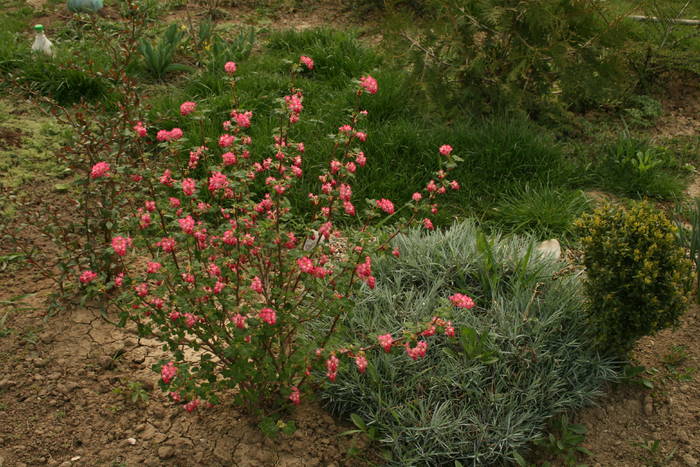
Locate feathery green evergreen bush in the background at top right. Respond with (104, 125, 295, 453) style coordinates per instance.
(401, 0, 629, 112)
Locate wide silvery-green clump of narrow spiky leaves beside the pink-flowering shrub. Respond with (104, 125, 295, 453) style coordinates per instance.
(322, 222, 615, 465)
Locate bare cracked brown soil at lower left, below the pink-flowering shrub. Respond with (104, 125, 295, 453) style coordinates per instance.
(0, 270, 360, 467)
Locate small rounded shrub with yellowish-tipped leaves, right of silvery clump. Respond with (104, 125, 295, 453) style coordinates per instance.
(577, 203, 691, 356)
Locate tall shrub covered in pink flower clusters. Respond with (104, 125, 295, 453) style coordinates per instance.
(98, 57, 473, 413)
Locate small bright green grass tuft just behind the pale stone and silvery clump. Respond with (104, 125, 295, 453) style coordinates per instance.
(491, 184, 589, 239)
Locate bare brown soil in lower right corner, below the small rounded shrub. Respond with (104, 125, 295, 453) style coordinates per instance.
(580, 305, 700, 467)
